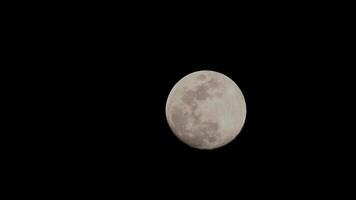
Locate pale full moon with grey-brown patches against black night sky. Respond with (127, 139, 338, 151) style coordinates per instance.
(166, 70, 246, 149)
